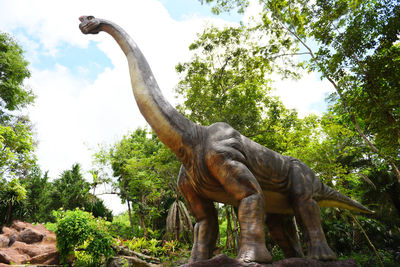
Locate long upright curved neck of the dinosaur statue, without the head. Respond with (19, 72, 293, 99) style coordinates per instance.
(100, 20, 196, 157)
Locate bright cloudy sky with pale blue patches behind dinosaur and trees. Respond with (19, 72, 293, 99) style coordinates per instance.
(0, 0, 332, 214)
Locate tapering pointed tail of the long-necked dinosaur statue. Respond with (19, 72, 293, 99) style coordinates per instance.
(315, 184, 375, 214)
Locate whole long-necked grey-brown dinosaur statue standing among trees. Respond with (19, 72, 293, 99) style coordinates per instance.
(79, 16, 373, 263)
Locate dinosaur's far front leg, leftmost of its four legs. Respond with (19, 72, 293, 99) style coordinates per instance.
(178, 167, 219, 262)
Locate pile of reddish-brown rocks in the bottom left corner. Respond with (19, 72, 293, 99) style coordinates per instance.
(0, 221, 59, 264)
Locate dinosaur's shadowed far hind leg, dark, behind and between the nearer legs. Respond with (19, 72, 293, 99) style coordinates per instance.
(265, 213, 304, 258)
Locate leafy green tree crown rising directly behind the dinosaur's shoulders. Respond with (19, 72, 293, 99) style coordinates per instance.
(176, 24, 300, 136)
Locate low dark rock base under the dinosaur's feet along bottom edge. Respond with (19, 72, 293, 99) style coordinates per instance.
(181, 254, 357, 267)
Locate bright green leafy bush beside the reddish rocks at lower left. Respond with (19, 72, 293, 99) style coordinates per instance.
(55, 209, 113, 266)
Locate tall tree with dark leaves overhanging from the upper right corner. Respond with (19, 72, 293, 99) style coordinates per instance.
(202, 0, 400, 209)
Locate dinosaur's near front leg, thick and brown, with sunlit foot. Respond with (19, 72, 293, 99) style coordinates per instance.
(208, 157, 272, 263)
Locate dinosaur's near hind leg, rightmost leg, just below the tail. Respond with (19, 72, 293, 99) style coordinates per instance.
(289, 163, 336, 261)
